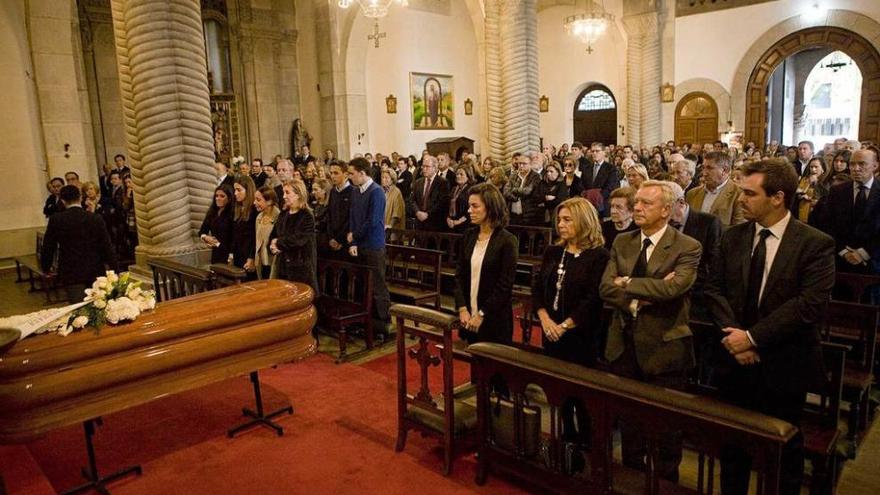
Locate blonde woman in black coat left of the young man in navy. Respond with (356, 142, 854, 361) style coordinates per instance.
(269, 180, 318, 295)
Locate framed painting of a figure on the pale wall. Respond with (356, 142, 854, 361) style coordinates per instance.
(409, 72, 455, 130)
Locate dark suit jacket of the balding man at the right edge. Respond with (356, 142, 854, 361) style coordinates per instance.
(818, 181, 880, 273)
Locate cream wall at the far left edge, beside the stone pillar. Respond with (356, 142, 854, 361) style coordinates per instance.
(0, 0, 47, 259)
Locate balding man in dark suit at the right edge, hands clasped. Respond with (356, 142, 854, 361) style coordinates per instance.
(818, 149, 880, 282)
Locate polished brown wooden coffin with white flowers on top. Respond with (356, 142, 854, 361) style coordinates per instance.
(0, 280, 317, 443)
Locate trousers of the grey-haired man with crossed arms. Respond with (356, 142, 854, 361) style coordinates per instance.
(611, 329, 687, 483)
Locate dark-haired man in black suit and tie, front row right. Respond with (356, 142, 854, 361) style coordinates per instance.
(706, 160, 834, 495)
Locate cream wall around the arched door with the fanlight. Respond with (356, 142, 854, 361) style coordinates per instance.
(538, 1, 626, 146)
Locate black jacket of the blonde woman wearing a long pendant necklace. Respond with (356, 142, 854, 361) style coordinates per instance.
(532, 246, 609, 366)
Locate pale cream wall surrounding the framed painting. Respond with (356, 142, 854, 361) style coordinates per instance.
(346, 0, 484, 156)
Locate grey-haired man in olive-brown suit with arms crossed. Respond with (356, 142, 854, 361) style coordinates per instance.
(599, 180, 702, 482)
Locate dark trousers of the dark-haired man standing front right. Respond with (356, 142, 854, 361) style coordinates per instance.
(720, 365, 806, 495)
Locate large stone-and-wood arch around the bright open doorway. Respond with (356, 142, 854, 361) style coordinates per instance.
(731, 10, 880, 147)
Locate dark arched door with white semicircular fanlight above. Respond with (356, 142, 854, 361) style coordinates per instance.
(573, 84, 617, 146)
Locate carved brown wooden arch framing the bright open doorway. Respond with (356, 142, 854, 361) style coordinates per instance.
(745, 26, 880, 147)
